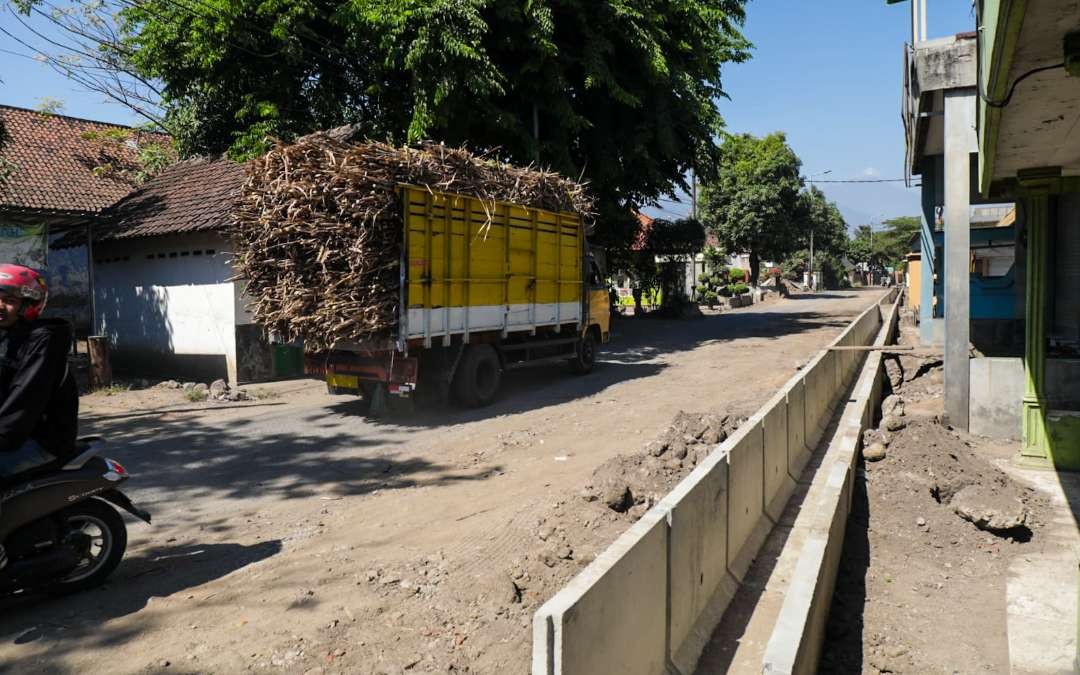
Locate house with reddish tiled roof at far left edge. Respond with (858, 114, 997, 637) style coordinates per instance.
(0, 105, 168, 336)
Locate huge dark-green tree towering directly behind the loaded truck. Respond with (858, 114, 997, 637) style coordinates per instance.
(17, 0, 751, 246)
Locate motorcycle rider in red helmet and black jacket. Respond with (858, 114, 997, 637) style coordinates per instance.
(0, 264, 79, 569)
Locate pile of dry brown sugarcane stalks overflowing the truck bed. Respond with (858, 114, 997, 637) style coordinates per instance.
(233, 132, 592, 351)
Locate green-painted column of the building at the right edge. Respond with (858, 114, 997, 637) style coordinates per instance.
(1021, 194, 1051, 463)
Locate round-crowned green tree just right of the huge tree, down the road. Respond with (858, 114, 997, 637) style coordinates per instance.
(700, 132, 805, 283)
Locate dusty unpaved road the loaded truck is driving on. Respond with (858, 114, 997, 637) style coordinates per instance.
(0, 291, 880, 674)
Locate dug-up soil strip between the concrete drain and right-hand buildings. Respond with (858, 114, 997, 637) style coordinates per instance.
(821, 321, 1050, 675)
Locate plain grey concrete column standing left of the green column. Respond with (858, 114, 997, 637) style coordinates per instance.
(945, 90, 977, 431)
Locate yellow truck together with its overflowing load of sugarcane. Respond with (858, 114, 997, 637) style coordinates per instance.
(233, 130, 610, 406)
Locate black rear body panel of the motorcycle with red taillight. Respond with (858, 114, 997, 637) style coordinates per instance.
(0, 457, 126, 542)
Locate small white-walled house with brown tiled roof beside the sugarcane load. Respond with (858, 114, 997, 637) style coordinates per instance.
(86, 158, 302, 383)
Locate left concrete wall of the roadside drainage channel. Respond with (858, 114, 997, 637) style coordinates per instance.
(532, 293, 892, 675)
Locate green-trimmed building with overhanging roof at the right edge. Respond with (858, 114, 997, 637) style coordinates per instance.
(976, 0, 1080, 470)
